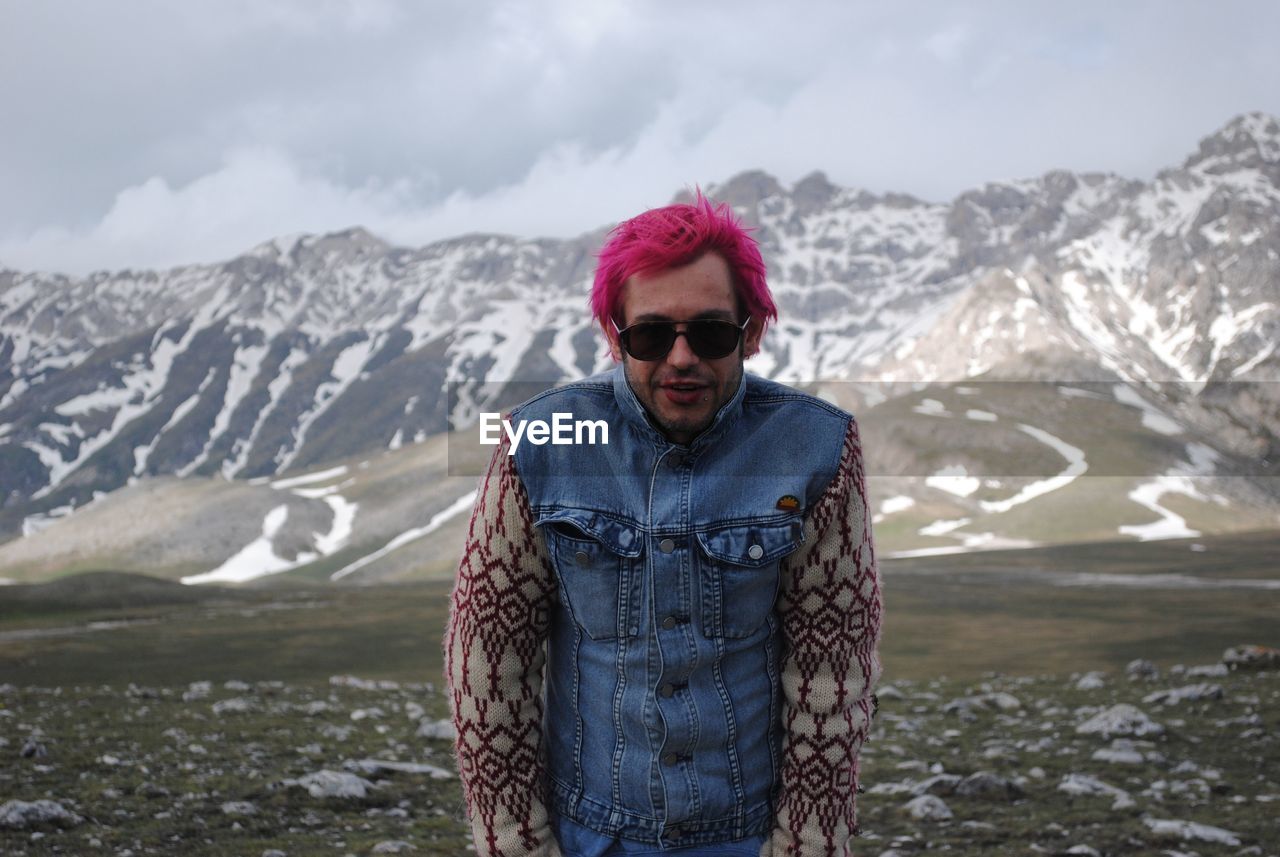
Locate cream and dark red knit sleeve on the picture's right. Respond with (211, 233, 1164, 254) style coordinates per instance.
(760, 420, 882, 857)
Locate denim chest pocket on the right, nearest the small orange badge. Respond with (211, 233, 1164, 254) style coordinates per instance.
(698, 518, 804, 638)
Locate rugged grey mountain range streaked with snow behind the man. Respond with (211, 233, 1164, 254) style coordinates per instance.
(0, 114, 1280, 583)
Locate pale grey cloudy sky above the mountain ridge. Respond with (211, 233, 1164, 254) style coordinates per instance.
(0, 0, 1280, 272)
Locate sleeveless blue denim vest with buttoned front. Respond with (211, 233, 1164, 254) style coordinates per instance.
(511, 365, 851, 847)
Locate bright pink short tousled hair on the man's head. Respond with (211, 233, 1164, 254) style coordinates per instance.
(591, 189, 778, 335)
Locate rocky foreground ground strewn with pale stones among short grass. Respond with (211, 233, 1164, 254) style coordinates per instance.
(0, 661, 1280, 857)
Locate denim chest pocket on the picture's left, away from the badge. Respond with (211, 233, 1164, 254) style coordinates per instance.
(538, 513, 641, 640)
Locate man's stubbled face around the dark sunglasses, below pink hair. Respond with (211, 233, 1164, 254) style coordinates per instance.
(607, 252, 760, 445)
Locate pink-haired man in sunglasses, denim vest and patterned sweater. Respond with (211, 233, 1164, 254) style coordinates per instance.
(445, 193, 882, 857)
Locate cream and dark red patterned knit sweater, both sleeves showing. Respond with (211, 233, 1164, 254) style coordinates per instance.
(444, 421, 882, 857)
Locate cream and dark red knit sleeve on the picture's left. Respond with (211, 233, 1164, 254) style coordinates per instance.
(444, 441, 561, 857)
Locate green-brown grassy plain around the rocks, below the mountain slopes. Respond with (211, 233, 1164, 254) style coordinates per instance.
(0, 533, 1280, 856)
